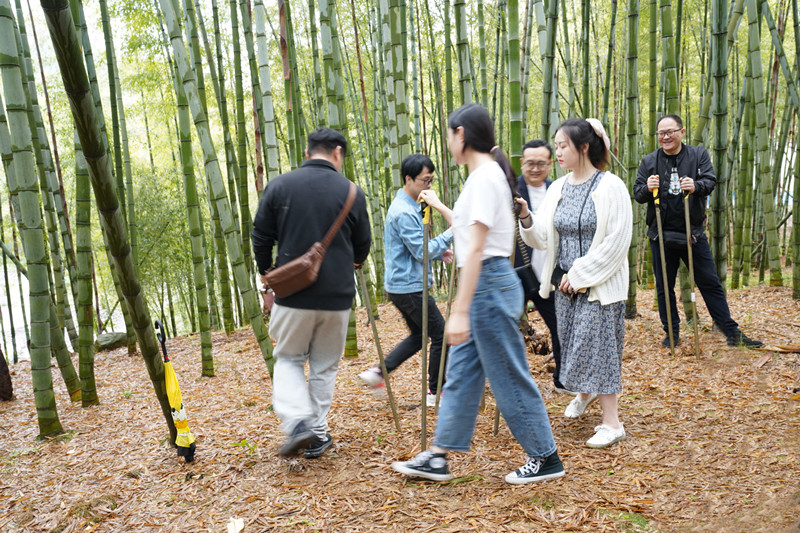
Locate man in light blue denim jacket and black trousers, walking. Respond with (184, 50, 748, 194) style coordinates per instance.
(358, 154, 453, 407)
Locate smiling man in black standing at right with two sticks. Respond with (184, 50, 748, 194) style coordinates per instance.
(633, 115, 762, 347)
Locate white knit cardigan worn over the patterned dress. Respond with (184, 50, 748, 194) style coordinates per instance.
(520, 172, 633, 305)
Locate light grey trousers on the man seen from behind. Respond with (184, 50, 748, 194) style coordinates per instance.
(269, 304, 350, 437)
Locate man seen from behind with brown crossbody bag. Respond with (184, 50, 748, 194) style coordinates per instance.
(252, 128, 372, 458)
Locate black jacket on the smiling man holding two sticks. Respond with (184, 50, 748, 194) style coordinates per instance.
(633, 144, 717, 239)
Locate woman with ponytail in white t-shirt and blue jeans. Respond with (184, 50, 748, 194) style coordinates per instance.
(392, 104, 564, 484)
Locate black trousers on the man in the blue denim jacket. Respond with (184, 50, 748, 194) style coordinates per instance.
(386, 292, 447, 394)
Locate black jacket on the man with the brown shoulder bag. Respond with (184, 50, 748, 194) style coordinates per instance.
(252, 159, 372, 311)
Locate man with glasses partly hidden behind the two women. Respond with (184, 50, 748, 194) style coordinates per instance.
(514, 139, 565, 392)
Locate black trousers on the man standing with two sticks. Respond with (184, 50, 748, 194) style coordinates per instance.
(650, 234, 739, 338)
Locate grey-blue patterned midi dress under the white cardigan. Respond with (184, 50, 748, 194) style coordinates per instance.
(553, 179, 625, 394)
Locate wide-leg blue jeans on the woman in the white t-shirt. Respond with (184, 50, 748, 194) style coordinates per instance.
(434, 257, 556, 457)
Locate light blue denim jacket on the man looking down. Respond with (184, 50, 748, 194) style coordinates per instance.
(383, 189, 453, 294)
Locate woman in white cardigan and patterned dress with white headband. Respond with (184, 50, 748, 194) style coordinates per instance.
(517, 118, 633, 448)
